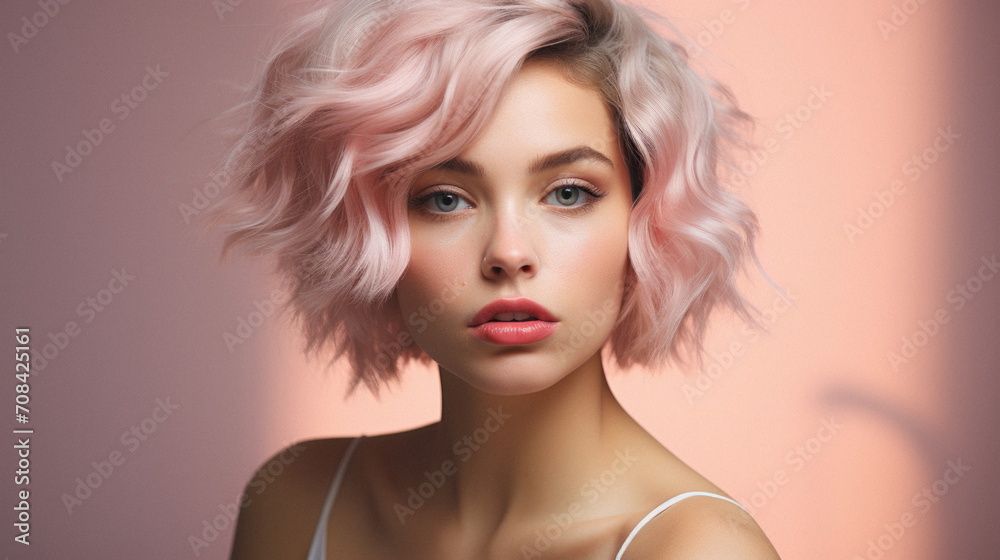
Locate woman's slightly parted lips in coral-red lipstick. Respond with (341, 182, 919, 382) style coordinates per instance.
(469, 297, 559, 346)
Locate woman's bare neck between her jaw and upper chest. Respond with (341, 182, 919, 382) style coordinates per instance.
(434, 353, 631, 524)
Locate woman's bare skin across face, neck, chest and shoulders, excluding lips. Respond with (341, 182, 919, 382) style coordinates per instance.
(232, 61, 778, 560)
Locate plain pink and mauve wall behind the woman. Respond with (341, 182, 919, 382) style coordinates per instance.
(0, 0, 1000, 560)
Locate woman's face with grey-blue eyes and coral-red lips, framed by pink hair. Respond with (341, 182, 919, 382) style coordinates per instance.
(397, 61, 632, 395)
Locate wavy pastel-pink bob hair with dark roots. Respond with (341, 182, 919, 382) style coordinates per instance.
(216, 0, 758, 391)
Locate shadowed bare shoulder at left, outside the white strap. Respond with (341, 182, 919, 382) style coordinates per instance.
(230, 438, 360, 560)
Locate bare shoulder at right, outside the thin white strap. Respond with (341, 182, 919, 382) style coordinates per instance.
(623, 496, 780, 560)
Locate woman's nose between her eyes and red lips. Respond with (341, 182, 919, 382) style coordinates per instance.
(482, 211, 538, 280)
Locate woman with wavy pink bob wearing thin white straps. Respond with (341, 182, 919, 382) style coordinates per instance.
(217, 0, 777, 560)
